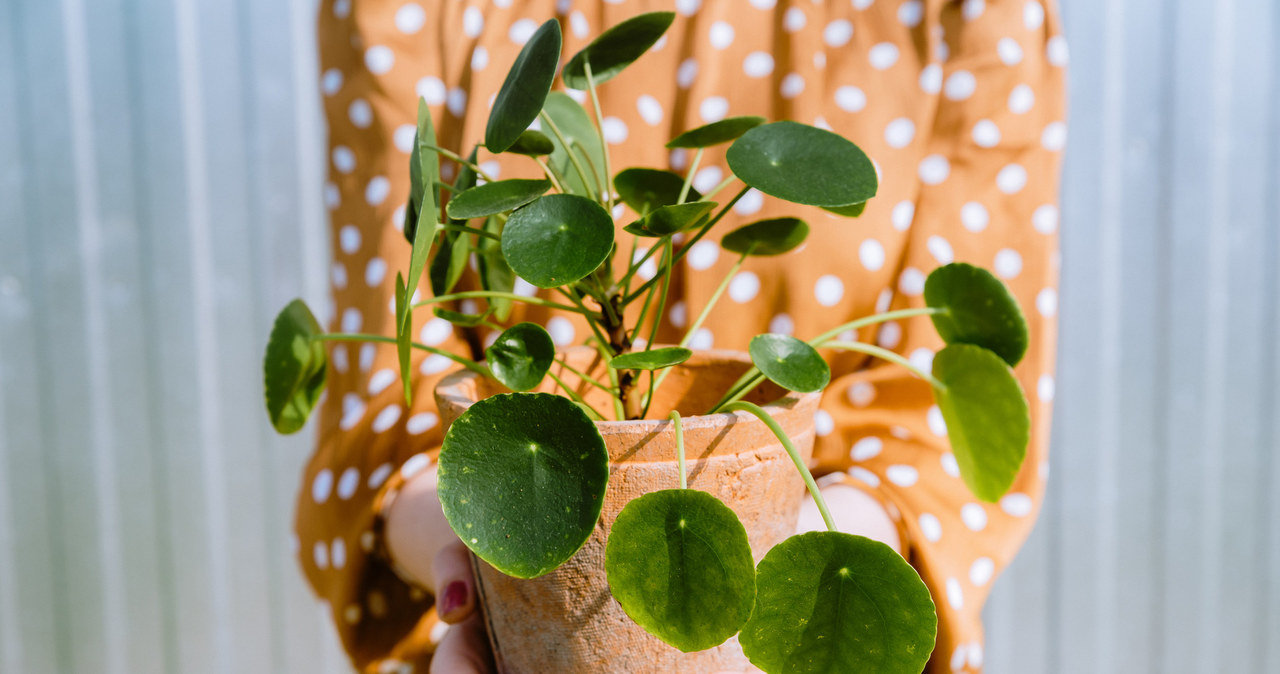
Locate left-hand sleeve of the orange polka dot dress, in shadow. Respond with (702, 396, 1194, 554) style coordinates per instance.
(294, 0, 476, 673)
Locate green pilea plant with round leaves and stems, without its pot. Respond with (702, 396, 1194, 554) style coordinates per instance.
(264, 13, 1029, 673)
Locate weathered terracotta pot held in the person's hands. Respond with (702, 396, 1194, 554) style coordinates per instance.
(435, 347, 820, 674)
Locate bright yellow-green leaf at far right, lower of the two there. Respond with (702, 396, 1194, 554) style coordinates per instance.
(933, 344, 1030, 503)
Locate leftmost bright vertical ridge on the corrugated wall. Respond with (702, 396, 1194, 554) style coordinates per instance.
(61, 0, 128, 674)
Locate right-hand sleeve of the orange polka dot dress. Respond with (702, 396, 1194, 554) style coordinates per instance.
(815, 3, 1065, 673)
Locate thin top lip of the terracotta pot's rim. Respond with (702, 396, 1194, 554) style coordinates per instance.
(435, 345, 824, 435)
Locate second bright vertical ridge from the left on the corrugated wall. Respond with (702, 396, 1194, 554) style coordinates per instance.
(174, 0, 233, 674)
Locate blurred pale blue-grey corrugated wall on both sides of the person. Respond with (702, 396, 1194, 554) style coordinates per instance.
(0, 0, 1280, 674)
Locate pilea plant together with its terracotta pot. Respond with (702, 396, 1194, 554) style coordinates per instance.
(264, 13, 1029, 673)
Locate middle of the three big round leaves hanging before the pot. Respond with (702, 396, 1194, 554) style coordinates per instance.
(604, 489, 755, 652)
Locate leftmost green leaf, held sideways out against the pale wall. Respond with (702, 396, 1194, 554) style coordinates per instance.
(262, 299, 329, 434)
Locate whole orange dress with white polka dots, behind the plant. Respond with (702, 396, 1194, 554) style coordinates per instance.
(296, 0, 1068, 673)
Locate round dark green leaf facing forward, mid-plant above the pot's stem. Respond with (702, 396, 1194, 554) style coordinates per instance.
(502, 194, 613, 288)
